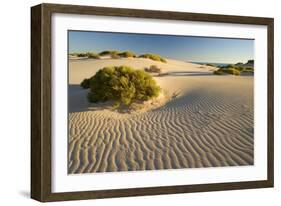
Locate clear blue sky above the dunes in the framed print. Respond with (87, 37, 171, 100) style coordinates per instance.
(69, 31, 254, 63)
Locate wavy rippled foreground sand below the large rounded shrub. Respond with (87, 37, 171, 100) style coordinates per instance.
(68, 84, 254, 173)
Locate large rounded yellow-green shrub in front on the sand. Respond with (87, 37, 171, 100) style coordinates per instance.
(84, 66, 160, 108)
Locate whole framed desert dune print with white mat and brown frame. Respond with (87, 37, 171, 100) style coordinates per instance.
(31, 4, 274, 202)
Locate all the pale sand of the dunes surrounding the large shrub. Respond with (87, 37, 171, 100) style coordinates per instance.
(68, 58, 254, 174)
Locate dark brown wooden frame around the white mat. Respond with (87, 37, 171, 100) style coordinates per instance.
(31, 4, 274, 202)
